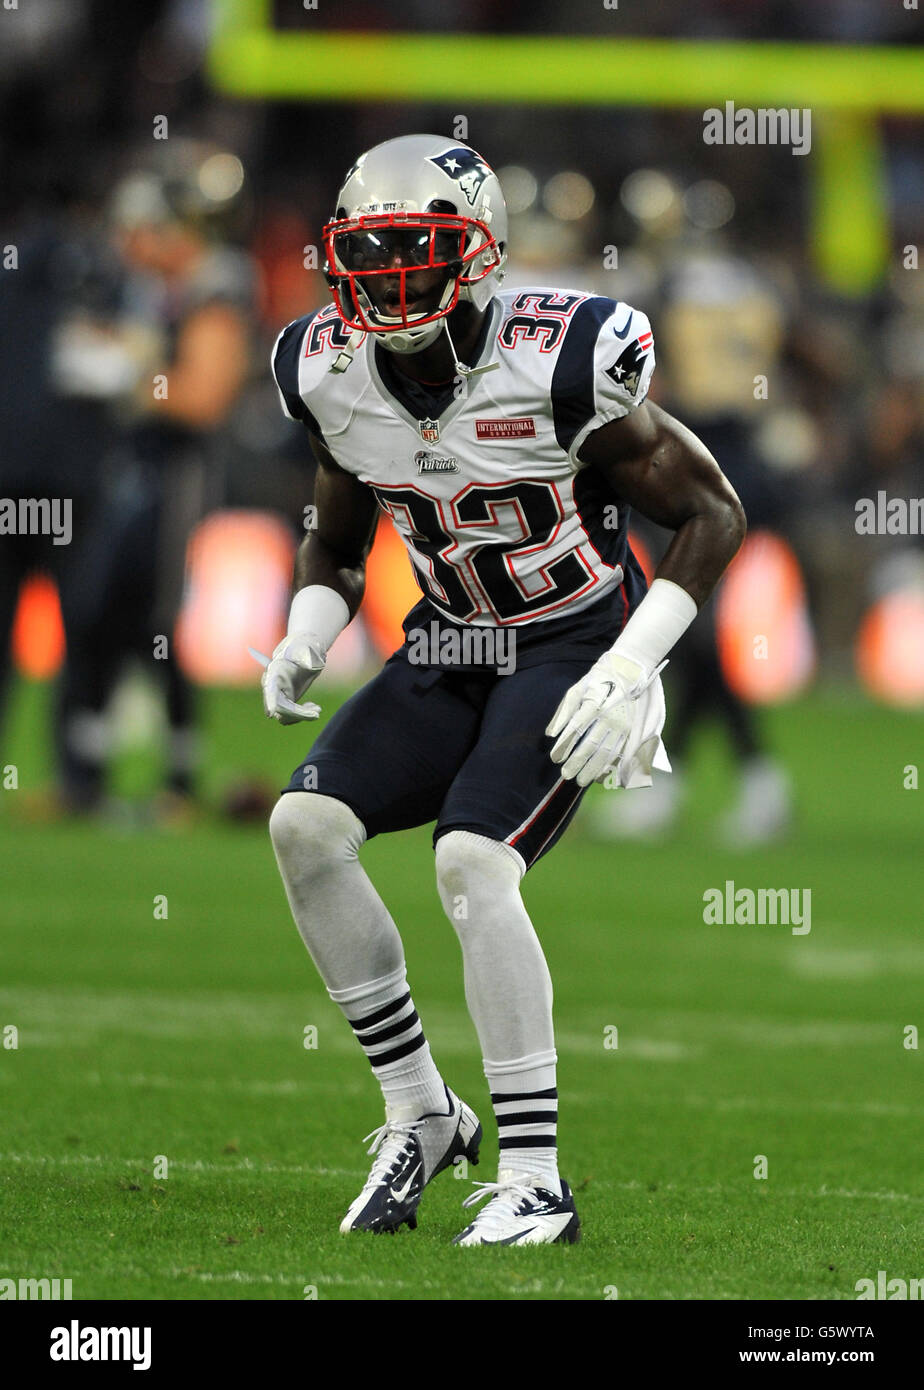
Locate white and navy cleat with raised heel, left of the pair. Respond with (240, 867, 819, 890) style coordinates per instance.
(340, 1087, 481, 1236)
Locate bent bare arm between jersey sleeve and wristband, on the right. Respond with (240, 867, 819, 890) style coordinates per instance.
(579, 400, 746, 607)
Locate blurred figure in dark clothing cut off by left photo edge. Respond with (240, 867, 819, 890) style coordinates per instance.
(0, 207, 126, 801)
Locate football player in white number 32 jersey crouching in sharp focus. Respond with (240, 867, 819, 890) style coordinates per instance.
(263, 135, 745, 1245)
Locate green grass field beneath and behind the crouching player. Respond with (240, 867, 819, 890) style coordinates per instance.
(0, 687, 924, 1300)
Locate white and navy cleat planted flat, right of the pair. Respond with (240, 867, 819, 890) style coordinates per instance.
(453, 1173, 581, 1245)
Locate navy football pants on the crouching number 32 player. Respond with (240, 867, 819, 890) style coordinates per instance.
(283, 653, 591, 869)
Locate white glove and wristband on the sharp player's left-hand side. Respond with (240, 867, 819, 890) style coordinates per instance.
(249, 584, 350, 724)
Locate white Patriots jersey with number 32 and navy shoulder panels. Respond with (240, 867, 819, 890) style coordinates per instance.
(272, 288, 654, 626)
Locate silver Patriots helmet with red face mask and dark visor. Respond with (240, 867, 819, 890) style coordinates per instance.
(324, 135, 507, 353)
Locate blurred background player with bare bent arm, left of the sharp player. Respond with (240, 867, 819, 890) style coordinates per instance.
(64, 142, 254, 819)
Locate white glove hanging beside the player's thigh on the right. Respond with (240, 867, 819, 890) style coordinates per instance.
(546, 652, 667, 787)
